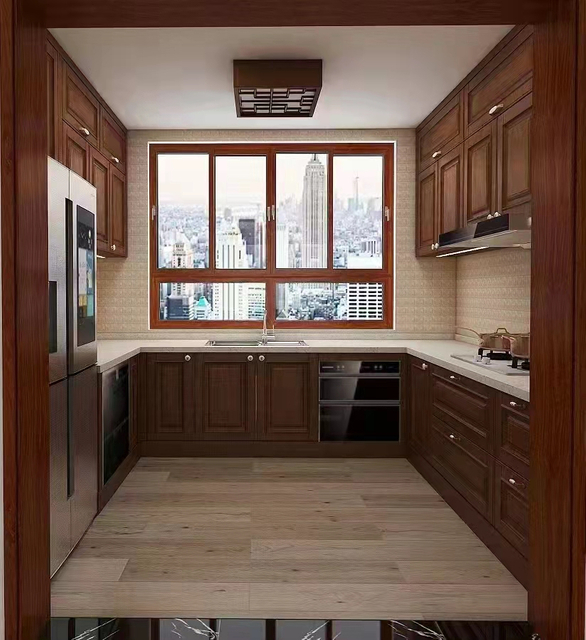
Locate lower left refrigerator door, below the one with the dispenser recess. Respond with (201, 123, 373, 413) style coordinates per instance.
(49, 380, 71, 576)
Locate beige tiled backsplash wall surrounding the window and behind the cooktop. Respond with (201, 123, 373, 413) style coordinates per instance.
(98, 129, 529, 338)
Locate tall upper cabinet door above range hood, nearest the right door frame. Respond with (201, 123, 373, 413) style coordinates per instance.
(497, 94, 533, 213)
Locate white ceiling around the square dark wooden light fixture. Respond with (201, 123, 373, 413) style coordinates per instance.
(52, 26, 510, 129)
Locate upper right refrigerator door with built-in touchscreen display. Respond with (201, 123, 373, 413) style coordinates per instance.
(67, 173, 97, 375)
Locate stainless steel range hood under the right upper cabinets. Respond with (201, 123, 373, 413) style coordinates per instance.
(438, 213, 531, 258)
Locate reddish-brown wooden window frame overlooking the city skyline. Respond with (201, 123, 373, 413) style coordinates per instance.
(149, 142, 395, 330)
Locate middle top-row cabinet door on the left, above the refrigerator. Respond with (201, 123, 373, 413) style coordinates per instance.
(63, 63, 100, 148)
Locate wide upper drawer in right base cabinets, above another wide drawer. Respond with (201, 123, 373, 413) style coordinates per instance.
(431, 366, 494, 453)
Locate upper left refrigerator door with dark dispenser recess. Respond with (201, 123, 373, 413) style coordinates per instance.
(48, 158, 69, 383)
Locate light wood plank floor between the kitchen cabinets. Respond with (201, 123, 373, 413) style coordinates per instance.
(52, 458, 527, 620)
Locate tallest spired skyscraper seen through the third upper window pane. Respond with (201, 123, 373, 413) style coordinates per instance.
(301, 153, 328, 269)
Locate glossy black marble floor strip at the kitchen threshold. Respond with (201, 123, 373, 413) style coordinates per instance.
(50, 618, 532, 640)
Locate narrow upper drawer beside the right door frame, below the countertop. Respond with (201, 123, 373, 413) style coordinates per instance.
(495, 394, 529, 478)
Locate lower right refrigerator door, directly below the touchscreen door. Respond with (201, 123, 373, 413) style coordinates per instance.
(68, 366, 98, 547)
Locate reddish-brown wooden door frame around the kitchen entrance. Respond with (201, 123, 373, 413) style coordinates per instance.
(0, 0, 586, 640)
